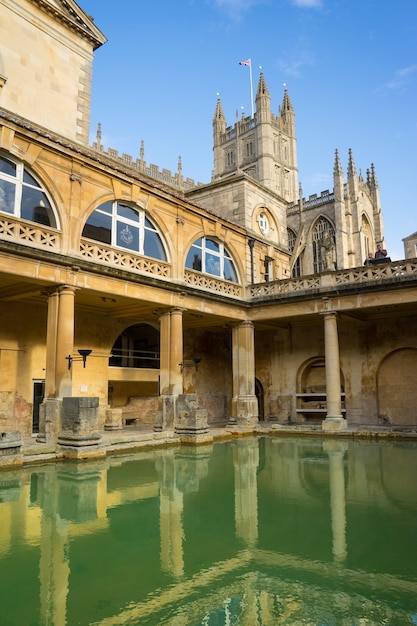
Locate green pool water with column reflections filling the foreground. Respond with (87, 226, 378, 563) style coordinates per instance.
(0, 437, 417, 626)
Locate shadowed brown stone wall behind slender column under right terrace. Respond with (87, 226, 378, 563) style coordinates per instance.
(256, 315, 417, 425)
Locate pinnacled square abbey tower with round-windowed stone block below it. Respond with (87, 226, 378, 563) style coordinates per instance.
(185, 72, 298, 282)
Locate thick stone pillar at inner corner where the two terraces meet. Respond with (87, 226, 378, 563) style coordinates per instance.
(231, 321, 258, 426)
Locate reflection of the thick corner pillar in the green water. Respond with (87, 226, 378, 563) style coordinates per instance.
(233, 439, 259, 545)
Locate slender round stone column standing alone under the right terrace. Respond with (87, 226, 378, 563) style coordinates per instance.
(322, 311, 347, 430)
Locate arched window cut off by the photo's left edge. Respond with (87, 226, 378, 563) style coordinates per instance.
(0, 157, 57, 228)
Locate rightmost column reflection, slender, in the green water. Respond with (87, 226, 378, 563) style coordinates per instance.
(323, 441, 347, 561)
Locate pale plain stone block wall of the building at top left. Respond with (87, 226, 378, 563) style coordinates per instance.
(0, 2, 100, 144)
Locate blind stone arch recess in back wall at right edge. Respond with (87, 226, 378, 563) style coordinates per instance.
(376, 348, 417, 425)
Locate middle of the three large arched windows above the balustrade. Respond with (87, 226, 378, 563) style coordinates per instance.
(82, 200, 167, 261)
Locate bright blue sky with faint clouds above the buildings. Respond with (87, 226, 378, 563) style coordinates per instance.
(78, 0, 417, 259)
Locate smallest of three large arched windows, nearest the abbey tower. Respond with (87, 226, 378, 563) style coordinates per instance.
(185, 237, 238, 283)
